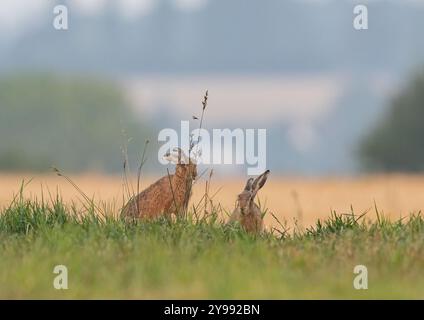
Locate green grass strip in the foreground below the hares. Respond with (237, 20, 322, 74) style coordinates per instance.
(0, 192, 424, 299)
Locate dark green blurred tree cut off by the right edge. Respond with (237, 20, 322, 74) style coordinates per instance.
(359, 70, 424, 172)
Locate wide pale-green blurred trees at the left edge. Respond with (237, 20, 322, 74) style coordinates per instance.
(0, 74, 150, 171)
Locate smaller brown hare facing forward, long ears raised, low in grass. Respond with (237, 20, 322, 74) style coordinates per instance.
(230, 170, 270, 233)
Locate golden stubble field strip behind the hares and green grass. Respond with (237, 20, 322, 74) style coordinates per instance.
(0, 173, 424, 227)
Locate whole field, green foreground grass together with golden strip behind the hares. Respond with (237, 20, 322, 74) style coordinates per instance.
(0, 174, 424, 299)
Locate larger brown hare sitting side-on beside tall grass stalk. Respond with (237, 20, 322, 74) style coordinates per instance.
(121, 148, 197, 218)
